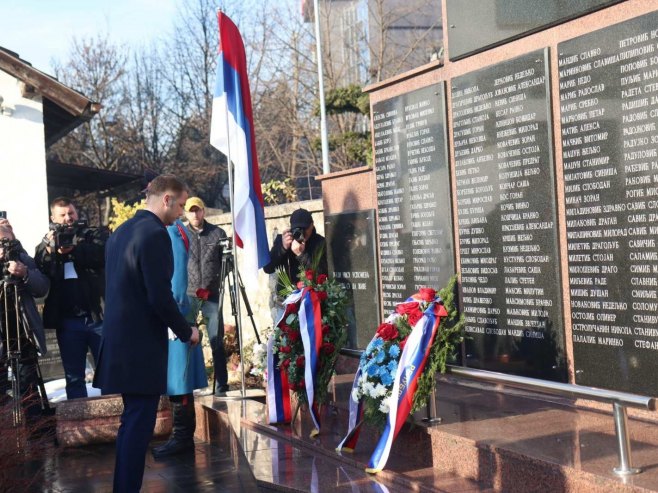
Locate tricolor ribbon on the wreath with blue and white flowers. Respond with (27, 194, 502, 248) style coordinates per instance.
(337, 297, 448, 474)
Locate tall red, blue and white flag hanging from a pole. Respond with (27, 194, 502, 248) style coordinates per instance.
(210, 12, 270, 286)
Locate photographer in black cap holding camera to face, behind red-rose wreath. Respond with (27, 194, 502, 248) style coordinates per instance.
(263, 209, 328, 293)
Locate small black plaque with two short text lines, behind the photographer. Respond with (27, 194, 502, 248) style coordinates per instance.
(324, 209, 381, 349)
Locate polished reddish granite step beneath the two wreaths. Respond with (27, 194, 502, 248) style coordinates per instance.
(197, 397, 493, 493)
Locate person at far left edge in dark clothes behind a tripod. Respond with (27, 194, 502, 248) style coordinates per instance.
(0, 221, 50, 422)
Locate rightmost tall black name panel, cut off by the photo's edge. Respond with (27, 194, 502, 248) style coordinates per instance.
(558, 13, 658, 395)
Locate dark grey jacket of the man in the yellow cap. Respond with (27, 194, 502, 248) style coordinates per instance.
(187, 221, 226, 302)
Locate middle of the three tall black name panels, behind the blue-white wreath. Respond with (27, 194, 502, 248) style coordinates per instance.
(452, 49, 567, 381)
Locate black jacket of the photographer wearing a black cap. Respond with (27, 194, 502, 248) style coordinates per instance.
(263, 229, 328, 293)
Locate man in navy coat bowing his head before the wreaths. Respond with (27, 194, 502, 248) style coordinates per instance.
(94, 175, 199, 493)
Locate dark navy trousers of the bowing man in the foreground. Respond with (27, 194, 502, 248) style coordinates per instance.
(114, 394, 160, 493)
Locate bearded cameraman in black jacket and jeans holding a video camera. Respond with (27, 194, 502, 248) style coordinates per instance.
(35, 197, 107, 399)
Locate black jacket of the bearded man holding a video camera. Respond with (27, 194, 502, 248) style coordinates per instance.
(34, 229, 107, 329)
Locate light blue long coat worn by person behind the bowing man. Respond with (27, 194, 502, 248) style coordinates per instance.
(167, 221, 208, 395)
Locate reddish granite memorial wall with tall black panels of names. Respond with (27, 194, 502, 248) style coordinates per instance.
(346, 0, 658, 396)
